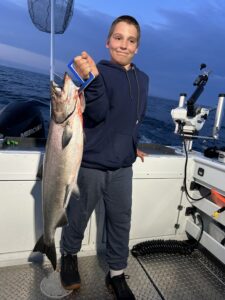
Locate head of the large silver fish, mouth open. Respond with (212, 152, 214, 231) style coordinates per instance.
(51, 73, 81, 124)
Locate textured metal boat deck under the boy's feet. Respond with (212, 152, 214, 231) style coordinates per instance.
(0, 250, 225, 300)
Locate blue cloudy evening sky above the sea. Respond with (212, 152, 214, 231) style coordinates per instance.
(0, 0, 225, 107)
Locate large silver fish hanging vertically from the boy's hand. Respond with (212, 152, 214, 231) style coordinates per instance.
(33, 73, 85, 270)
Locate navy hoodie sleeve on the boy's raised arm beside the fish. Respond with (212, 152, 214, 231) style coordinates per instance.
(85, 74, 109, 123)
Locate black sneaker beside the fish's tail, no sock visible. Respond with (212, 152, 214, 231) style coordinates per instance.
(60, 254, 81, 290)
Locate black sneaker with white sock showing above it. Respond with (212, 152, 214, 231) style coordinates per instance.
(105, 272, 135, 300)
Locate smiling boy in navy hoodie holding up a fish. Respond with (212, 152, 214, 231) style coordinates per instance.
(61, 15, 149, 299)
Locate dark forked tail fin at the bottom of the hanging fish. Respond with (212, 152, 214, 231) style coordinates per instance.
(33, 235, 57, 270)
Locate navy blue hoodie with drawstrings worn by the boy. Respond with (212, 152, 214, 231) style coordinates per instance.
(82, 61, 149, 170)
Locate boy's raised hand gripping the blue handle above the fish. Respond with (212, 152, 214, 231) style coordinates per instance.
(74, 51, 99, 79)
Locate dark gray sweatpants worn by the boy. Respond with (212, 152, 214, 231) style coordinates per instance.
(61, 167, 133, 270)
